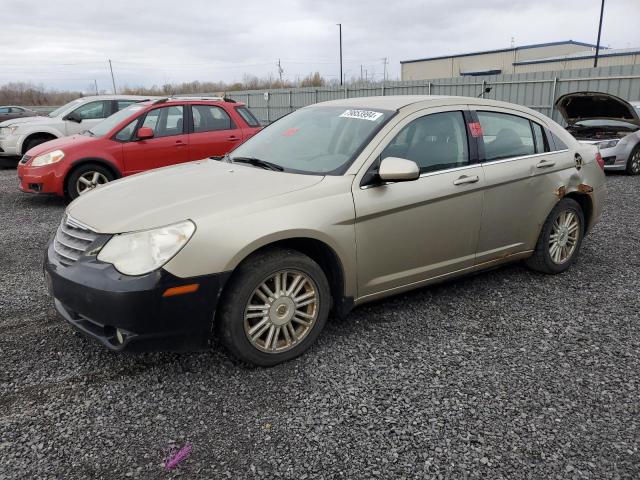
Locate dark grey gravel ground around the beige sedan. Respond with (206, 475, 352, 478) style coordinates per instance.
(0, 170, 640, 479)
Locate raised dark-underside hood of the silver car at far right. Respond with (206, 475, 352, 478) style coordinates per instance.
(555, 92, 640, 126)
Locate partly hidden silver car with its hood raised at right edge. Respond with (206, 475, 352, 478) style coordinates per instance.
(556, 92, 640, 175)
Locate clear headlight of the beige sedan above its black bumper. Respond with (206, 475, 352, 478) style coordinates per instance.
(98, 220, 196, 275)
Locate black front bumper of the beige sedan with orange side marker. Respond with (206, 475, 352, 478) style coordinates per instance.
(44, 239, 228, 351)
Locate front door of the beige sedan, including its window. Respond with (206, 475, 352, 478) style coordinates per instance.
(353, 107, 484, 298)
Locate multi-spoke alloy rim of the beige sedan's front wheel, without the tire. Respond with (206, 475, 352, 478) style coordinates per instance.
(244, 270, 320, 353)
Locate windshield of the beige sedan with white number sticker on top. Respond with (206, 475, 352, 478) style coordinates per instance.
(230, 106, 394, 175)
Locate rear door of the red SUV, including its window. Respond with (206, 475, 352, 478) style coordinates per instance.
(189, 104, 243, 160)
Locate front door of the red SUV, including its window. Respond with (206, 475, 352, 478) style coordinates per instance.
(122, 105, 189, 174)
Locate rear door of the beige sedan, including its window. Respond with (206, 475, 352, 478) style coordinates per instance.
(475, 106, 575, 264)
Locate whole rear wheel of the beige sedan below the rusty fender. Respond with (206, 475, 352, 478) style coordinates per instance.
(525, 198, 585, 274)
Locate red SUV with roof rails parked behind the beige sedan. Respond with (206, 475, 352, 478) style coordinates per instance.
(18, 97, 262, 199)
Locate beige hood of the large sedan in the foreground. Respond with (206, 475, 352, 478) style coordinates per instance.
(67, 160, 324, 233)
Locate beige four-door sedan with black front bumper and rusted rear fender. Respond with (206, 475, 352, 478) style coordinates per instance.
(44, 96, 605, 366)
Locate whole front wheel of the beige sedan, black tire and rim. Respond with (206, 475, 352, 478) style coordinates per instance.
(216, 249, 331, 367)
